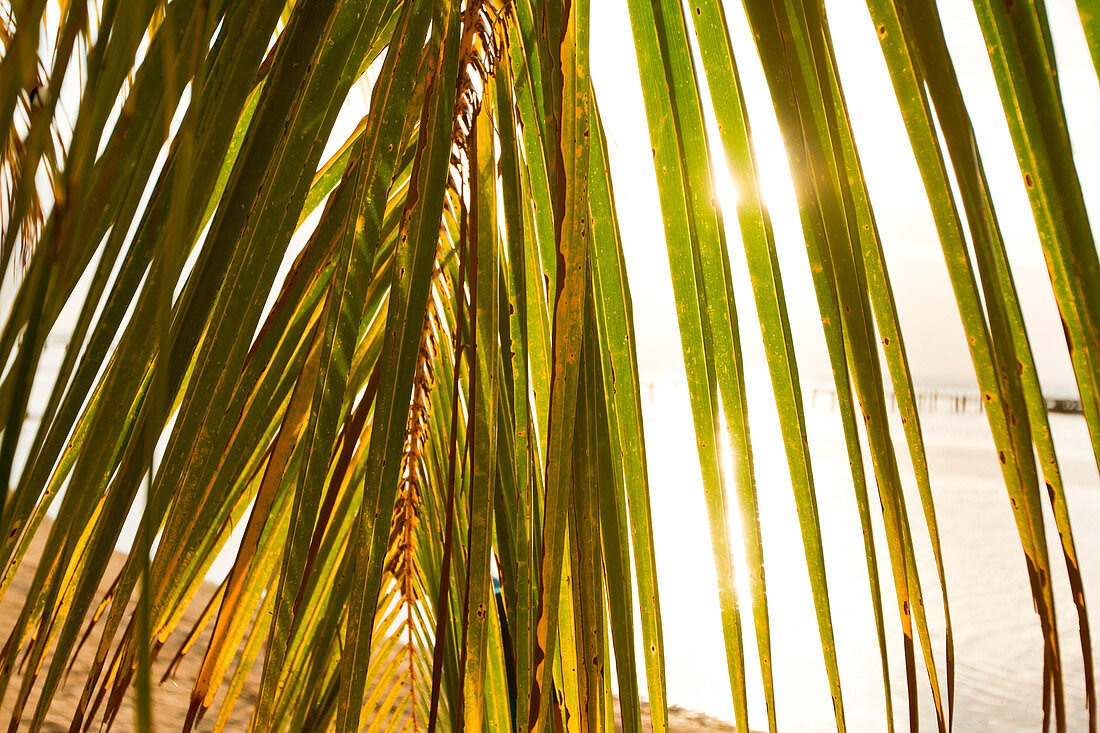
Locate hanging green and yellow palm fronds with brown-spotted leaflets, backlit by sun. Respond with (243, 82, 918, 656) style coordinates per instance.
(0, 0, 1100, 731)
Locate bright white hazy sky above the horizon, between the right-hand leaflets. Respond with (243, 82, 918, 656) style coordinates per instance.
(592, 0, 1100, 395)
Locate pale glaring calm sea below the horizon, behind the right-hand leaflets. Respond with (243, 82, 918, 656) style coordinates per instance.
(644, 382, 1100, 732)
